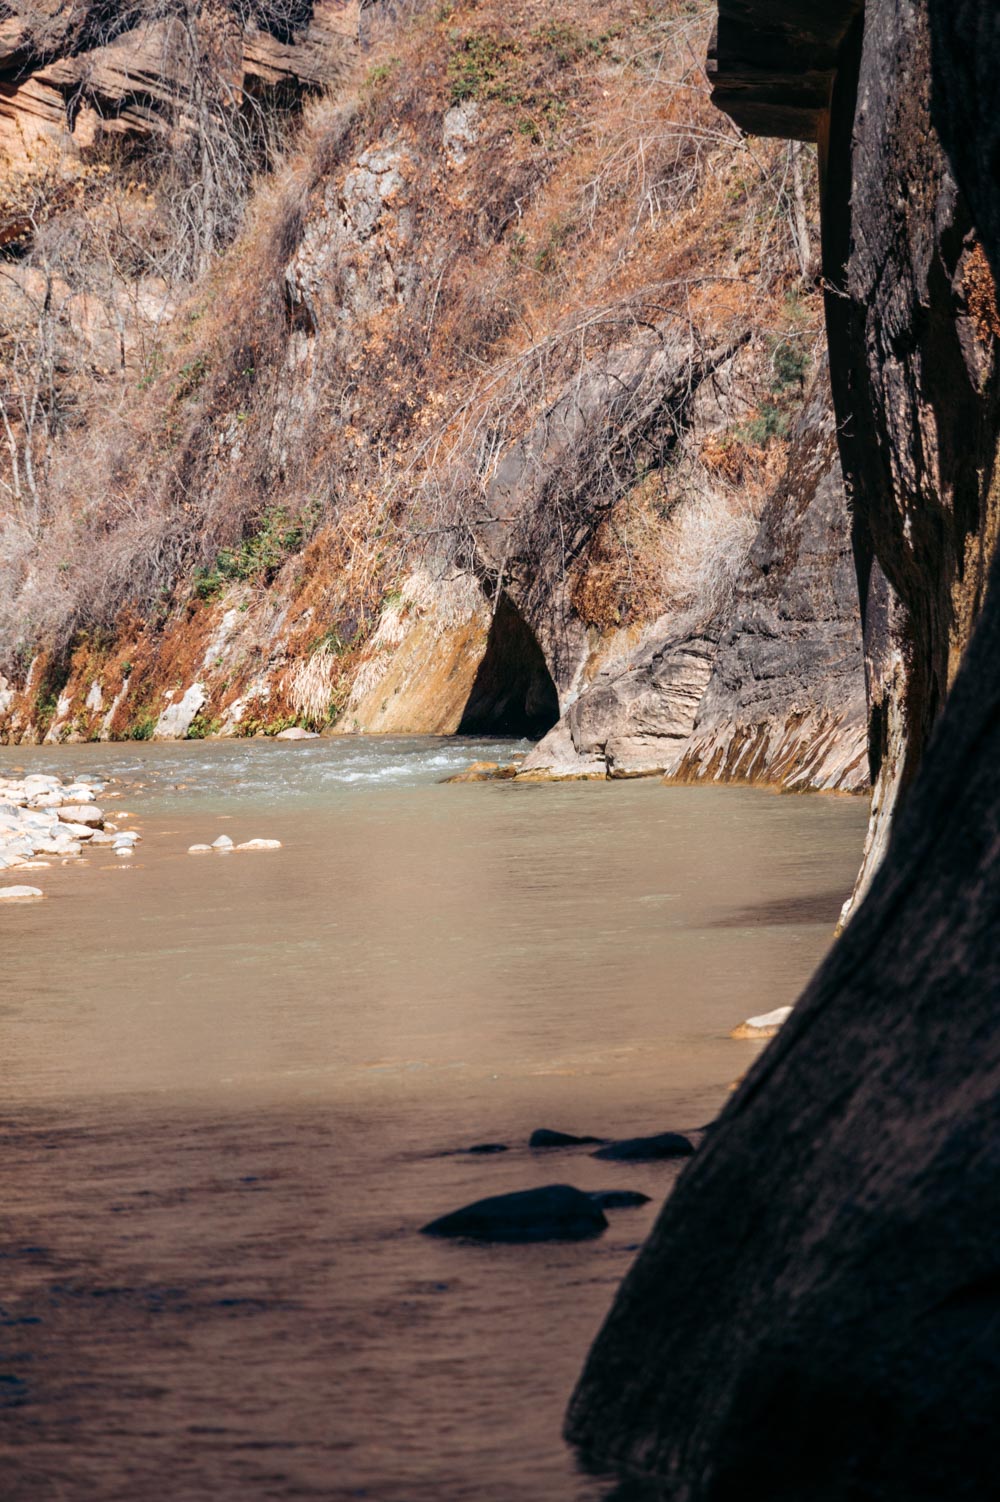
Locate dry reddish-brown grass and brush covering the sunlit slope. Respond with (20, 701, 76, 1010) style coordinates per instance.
(0, 0, 818, 720)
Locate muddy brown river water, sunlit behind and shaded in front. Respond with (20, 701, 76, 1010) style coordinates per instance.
(0, 739, 866, 1502)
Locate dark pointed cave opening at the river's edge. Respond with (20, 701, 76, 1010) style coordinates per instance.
(458, 593, 559, 740)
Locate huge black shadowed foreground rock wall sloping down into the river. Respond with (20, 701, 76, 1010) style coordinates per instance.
(569, 0, 1000, 1502)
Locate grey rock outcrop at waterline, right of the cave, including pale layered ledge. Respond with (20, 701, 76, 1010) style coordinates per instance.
(520, 372, 868, 792)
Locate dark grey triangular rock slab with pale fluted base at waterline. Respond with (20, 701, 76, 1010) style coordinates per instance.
(673, 361, 868, 792)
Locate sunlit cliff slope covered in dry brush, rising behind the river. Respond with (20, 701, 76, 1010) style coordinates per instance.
(0, 0, 866, 790)
